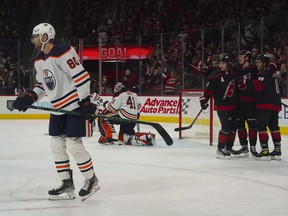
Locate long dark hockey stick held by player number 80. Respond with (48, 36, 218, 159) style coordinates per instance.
(27, 106, 173, 146)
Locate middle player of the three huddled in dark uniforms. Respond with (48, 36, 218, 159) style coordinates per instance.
(233, 50, 257, 156)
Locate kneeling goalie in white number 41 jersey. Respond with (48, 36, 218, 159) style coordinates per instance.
(93, 82, 156, 146)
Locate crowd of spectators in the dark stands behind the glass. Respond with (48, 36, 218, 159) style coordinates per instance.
(0, 0, 288, 96)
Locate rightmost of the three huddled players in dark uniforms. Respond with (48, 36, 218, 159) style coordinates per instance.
(247, 54, 281, 160)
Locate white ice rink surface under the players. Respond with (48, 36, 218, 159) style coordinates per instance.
(0, 120, 288, 216)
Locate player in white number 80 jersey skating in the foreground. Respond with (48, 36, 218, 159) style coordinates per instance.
(13, 23, 99, 200)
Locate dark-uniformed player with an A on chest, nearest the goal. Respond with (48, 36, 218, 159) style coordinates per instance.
(200, 54, 237, 158)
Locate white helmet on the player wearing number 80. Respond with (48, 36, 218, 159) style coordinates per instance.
(31, 23, 56, 50)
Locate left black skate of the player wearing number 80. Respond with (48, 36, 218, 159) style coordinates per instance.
(48, 170, 75, 200)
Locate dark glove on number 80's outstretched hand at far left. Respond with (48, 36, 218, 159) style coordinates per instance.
(13, 90, 38, 112)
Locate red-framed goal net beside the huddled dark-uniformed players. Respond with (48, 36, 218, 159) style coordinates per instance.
(179, 90, 214, 145)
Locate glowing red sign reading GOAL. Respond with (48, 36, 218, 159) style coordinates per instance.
(83, 45, 153, 60)
